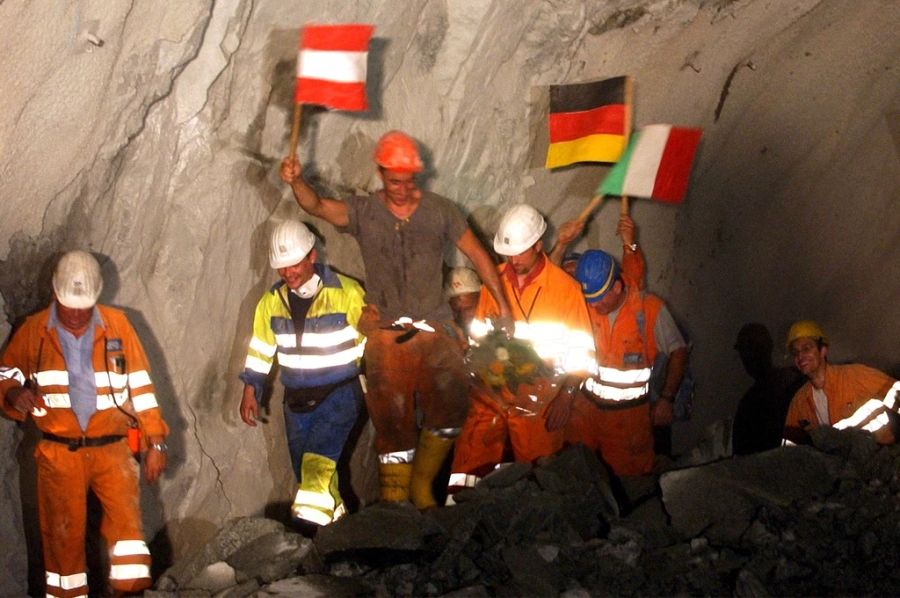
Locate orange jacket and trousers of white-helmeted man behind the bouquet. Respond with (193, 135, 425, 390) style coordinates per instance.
(451, 256, 593, 478)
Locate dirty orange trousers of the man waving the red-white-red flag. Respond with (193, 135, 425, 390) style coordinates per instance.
(365, 322, 469, 455)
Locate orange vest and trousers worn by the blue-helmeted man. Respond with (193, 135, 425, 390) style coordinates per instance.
(566, 286, 662, 475)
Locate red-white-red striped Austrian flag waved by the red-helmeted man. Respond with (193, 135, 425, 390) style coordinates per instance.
(294, 25, 374, 111)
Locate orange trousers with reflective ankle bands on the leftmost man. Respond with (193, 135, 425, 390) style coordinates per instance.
(35, 440, 151, 598)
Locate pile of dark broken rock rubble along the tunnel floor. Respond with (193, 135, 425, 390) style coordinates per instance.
(145, 429, 900, 598)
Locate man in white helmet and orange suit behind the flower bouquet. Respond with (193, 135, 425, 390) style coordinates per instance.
(449, 204, 594, 494)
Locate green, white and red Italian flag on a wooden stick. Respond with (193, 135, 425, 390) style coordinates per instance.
(596, 125, 703, 203)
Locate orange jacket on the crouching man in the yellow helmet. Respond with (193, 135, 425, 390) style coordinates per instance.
(784, 363, 895, 444)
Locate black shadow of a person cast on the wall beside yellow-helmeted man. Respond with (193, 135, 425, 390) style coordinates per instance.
(731, 322, 804, 455)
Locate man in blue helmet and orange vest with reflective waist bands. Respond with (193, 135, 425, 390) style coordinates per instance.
(567, 249, 688, 476)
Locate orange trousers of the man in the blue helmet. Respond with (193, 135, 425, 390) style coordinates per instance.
(566, 392, 654, 476)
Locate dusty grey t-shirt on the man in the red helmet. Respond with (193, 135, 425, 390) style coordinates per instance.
(344, 191, 468, 321)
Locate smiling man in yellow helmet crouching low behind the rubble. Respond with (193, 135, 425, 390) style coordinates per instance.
(784, 320, 900, 444)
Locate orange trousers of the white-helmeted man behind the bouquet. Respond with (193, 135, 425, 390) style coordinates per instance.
(451, 385, 564, 476)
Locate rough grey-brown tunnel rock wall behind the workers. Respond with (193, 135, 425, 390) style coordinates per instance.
(0, 0, 900, 580)
